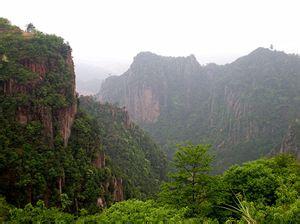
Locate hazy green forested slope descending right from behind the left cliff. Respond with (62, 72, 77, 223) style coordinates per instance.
(75, 97, 166, 198)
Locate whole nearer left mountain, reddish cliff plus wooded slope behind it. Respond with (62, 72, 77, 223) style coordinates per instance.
(0, 18, 165, 212)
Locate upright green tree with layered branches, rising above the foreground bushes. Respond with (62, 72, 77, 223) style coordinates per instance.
(160, 144, 213, 216)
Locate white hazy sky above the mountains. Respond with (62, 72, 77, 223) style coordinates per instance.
(0, 0, 300, 70)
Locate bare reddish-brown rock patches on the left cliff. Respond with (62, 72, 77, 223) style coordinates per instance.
(2, 51, 77, 146)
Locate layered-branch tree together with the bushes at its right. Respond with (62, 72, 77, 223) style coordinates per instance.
(159, 150, 300, 223)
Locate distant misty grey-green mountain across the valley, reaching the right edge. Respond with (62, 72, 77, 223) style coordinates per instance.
(98, 48, 300, 170)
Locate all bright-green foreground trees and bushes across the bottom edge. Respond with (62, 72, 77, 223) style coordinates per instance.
(0, 145, 300, 224)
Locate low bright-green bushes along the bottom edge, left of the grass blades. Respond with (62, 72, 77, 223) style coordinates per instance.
(0, 200, 217, 224)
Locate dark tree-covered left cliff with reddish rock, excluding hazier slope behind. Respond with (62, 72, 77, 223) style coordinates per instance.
(0, 18, 130, 210)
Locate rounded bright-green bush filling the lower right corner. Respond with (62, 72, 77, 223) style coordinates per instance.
(223, 154, 300, 223)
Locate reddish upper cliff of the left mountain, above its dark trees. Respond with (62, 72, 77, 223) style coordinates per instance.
(0, 22, 77, 146)
